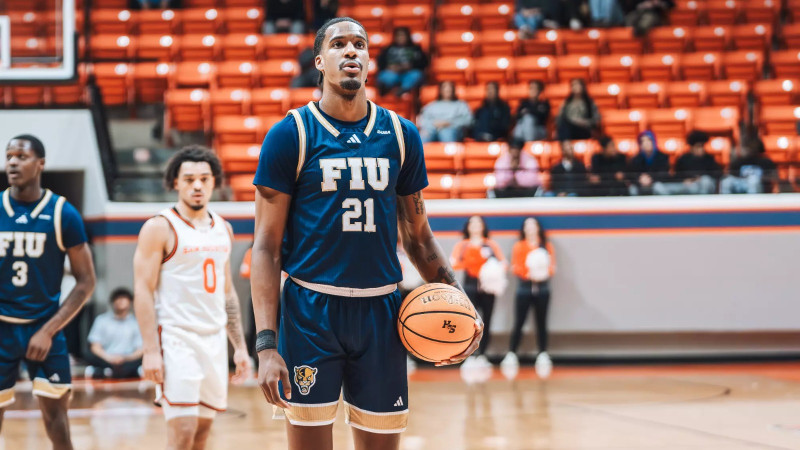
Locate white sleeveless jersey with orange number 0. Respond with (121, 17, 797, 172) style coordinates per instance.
(155, 208, 231, 334)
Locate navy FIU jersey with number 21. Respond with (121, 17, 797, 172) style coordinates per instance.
(253, 102, 428, 289)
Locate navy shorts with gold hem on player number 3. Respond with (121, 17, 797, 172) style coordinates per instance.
(0, 320, 72, 408)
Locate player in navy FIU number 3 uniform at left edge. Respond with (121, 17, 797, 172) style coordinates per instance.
(0, 135, 95, 450)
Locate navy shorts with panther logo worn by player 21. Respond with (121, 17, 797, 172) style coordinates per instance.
(278, 278, 408, 433)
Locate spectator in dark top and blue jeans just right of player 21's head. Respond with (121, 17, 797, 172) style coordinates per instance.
(378, 27, 428, 96)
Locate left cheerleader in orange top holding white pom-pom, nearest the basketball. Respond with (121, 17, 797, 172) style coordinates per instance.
(450, 216, 505, 367)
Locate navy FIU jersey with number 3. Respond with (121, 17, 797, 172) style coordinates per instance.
(0, 189, 86, 321)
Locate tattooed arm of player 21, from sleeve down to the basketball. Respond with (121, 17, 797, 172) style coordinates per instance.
(398, 192, 463, 290)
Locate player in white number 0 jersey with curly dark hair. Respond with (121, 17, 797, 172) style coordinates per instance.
(133, 146, 250, 450)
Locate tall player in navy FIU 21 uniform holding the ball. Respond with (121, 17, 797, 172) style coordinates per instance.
(251, 18, 483, 450)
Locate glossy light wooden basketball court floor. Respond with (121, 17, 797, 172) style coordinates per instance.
(0, 363, 800, 450)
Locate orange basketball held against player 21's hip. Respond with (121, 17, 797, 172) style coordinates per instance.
(397, 283, 476, 362)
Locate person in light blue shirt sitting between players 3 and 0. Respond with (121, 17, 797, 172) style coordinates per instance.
(85, 288, 142, 379)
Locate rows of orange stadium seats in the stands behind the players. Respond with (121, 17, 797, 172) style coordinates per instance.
(0, 0, 800, 200)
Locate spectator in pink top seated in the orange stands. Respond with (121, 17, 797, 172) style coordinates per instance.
(494, 140, 542, 197)
